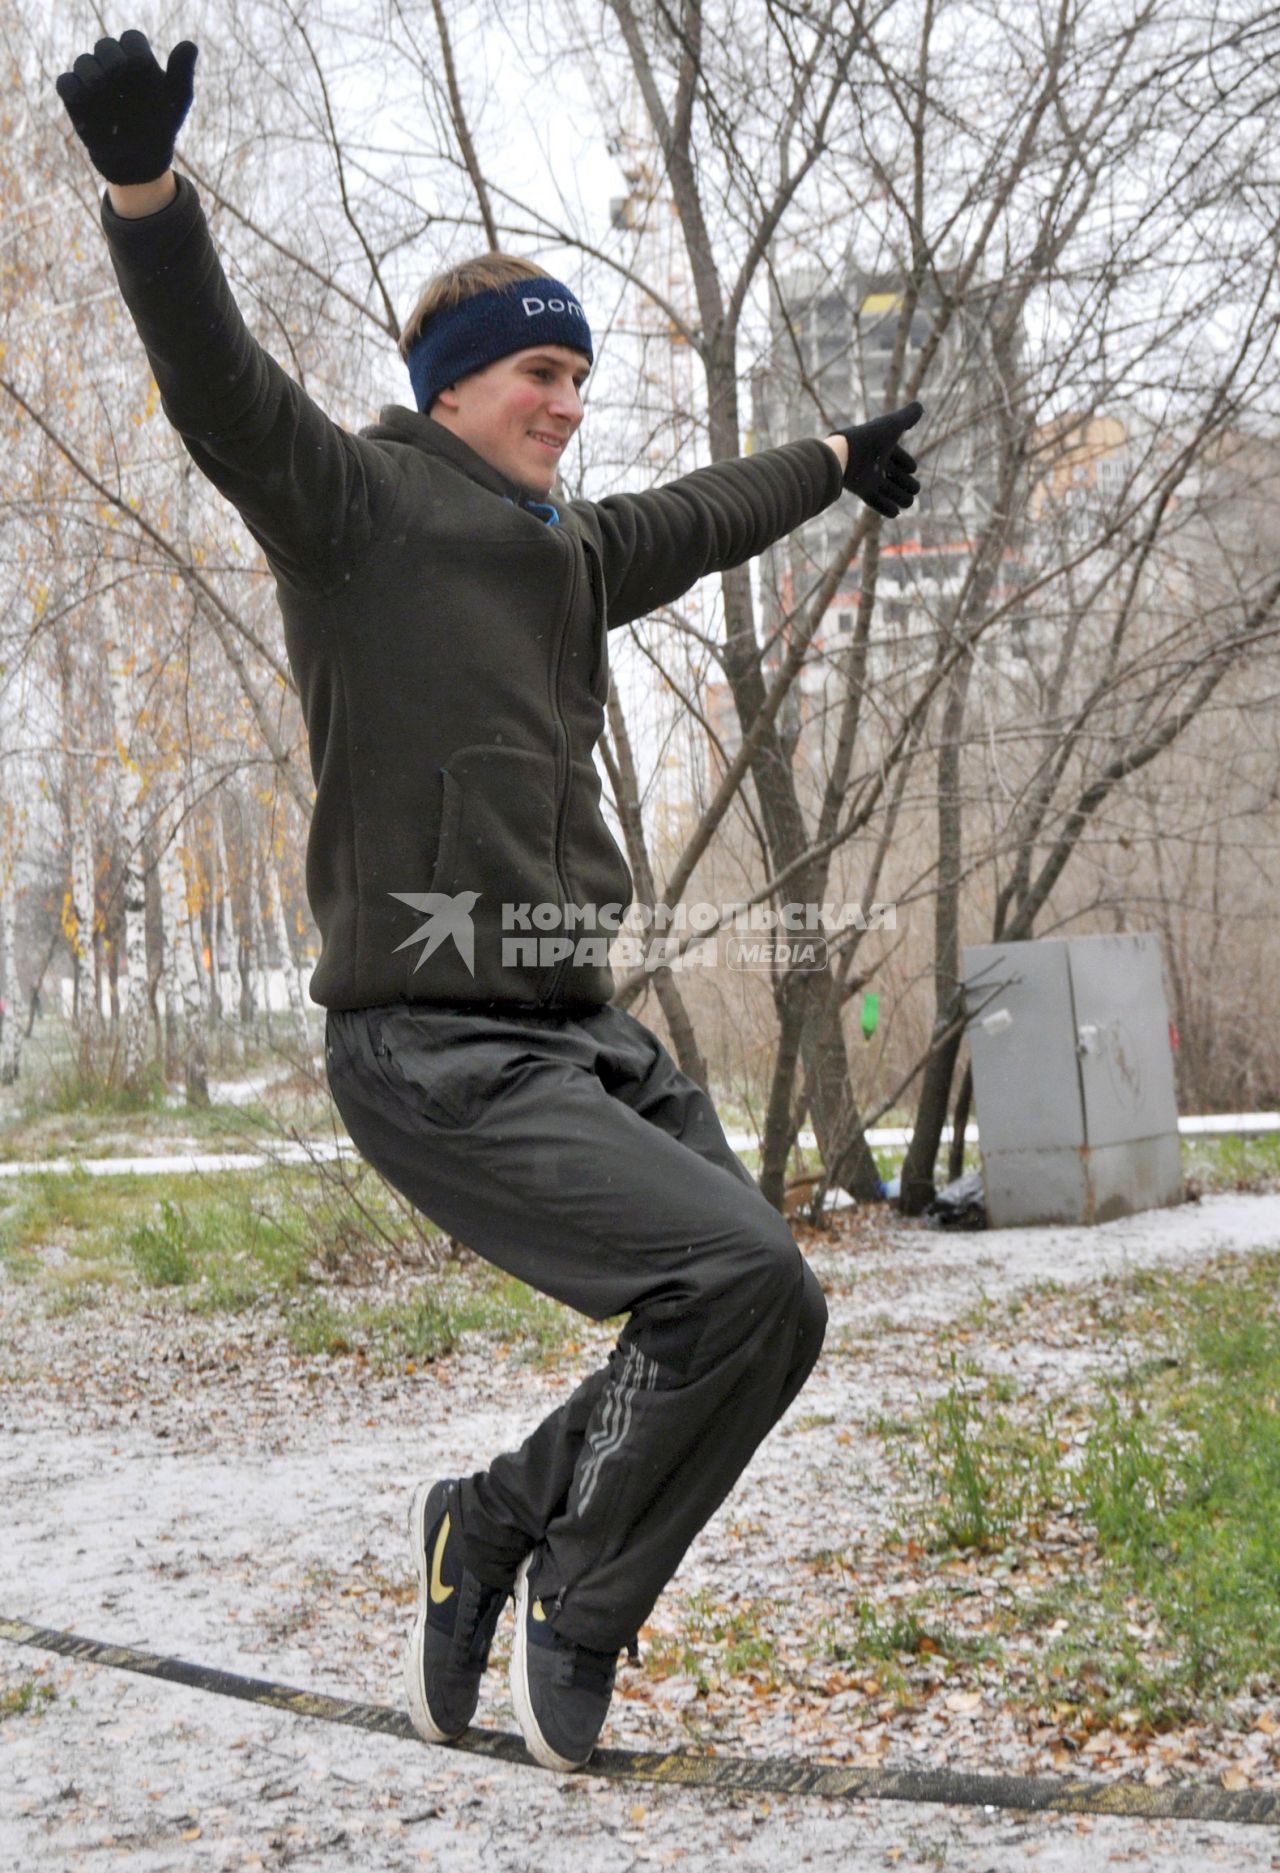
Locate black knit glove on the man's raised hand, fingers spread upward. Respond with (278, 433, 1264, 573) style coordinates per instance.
(58, 32, 197, 185)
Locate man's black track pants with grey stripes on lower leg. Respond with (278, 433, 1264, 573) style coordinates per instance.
(328, 1004, 826, 1650)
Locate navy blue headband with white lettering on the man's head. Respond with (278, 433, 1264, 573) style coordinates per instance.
(409, 279, 594, 410)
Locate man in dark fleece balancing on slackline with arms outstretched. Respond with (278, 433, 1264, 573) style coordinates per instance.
(58, 32, 922, 1768)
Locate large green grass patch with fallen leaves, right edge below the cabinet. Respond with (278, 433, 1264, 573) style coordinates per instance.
(922, 1253, 1280, 1733)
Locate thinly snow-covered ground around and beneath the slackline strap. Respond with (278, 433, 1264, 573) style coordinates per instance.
(0, 1195, 1280, 1873)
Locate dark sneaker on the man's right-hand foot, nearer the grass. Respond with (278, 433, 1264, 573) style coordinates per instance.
(512, 1555, 618, 1768)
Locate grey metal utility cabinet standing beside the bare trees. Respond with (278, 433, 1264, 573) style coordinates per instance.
(963, 937, 1183, 1229)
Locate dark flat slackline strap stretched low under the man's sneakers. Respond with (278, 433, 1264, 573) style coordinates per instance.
(0, 1615, 1280, 1822)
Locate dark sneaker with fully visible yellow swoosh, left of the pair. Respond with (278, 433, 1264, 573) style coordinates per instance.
(405, 1480, 508, 1744)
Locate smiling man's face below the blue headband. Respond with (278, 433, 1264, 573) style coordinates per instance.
(431, 345, 590, 494)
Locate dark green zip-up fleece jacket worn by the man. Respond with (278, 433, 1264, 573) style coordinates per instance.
(103, 178, 841, 1008)
